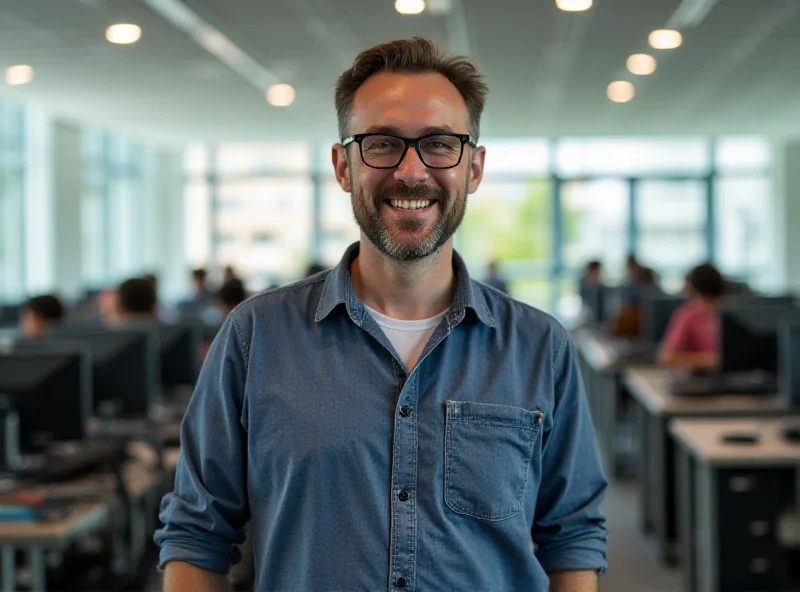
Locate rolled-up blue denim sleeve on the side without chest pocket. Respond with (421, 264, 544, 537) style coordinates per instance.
(155, 313, 249, 573)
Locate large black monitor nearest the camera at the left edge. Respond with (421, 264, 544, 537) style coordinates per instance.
(0, 344, 92, 452)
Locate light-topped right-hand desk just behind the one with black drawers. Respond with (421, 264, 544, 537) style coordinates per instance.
(623, 368, 788, 564)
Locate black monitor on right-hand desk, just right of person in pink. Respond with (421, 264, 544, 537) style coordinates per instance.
(719, 306, 800, 373)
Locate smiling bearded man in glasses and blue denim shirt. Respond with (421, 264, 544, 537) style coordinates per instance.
(156, 38, 606, 592)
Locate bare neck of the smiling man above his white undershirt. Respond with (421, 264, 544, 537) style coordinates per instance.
(350, 236, 456, 321)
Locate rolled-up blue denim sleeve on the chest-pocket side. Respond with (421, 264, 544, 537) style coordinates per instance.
(531, 336, 607, 573)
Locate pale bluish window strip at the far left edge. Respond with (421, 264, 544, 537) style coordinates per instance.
(0, 101, 26, 302)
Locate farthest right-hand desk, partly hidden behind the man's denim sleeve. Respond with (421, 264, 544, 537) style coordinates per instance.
(572, 328, 652, 477)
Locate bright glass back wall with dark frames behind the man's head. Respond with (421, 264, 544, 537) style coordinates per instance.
(186, 137, 771, 318)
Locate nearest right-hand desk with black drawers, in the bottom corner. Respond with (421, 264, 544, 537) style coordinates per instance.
(670, 419, 800, 592)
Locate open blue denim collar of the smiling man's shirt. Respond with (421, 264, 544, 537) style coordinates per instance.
(315, 243, 496, 329)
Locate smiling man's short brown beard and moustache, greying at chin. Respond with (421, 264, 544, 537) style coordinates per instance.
(351, 183, 467, 261)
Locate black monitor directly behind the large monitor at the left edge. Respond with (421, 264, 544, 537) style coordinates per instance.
(46, 326, 160, 417)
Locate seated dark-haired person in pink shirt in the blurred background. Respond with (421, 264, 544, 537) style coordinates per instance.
(658, 263, 725, 369)
